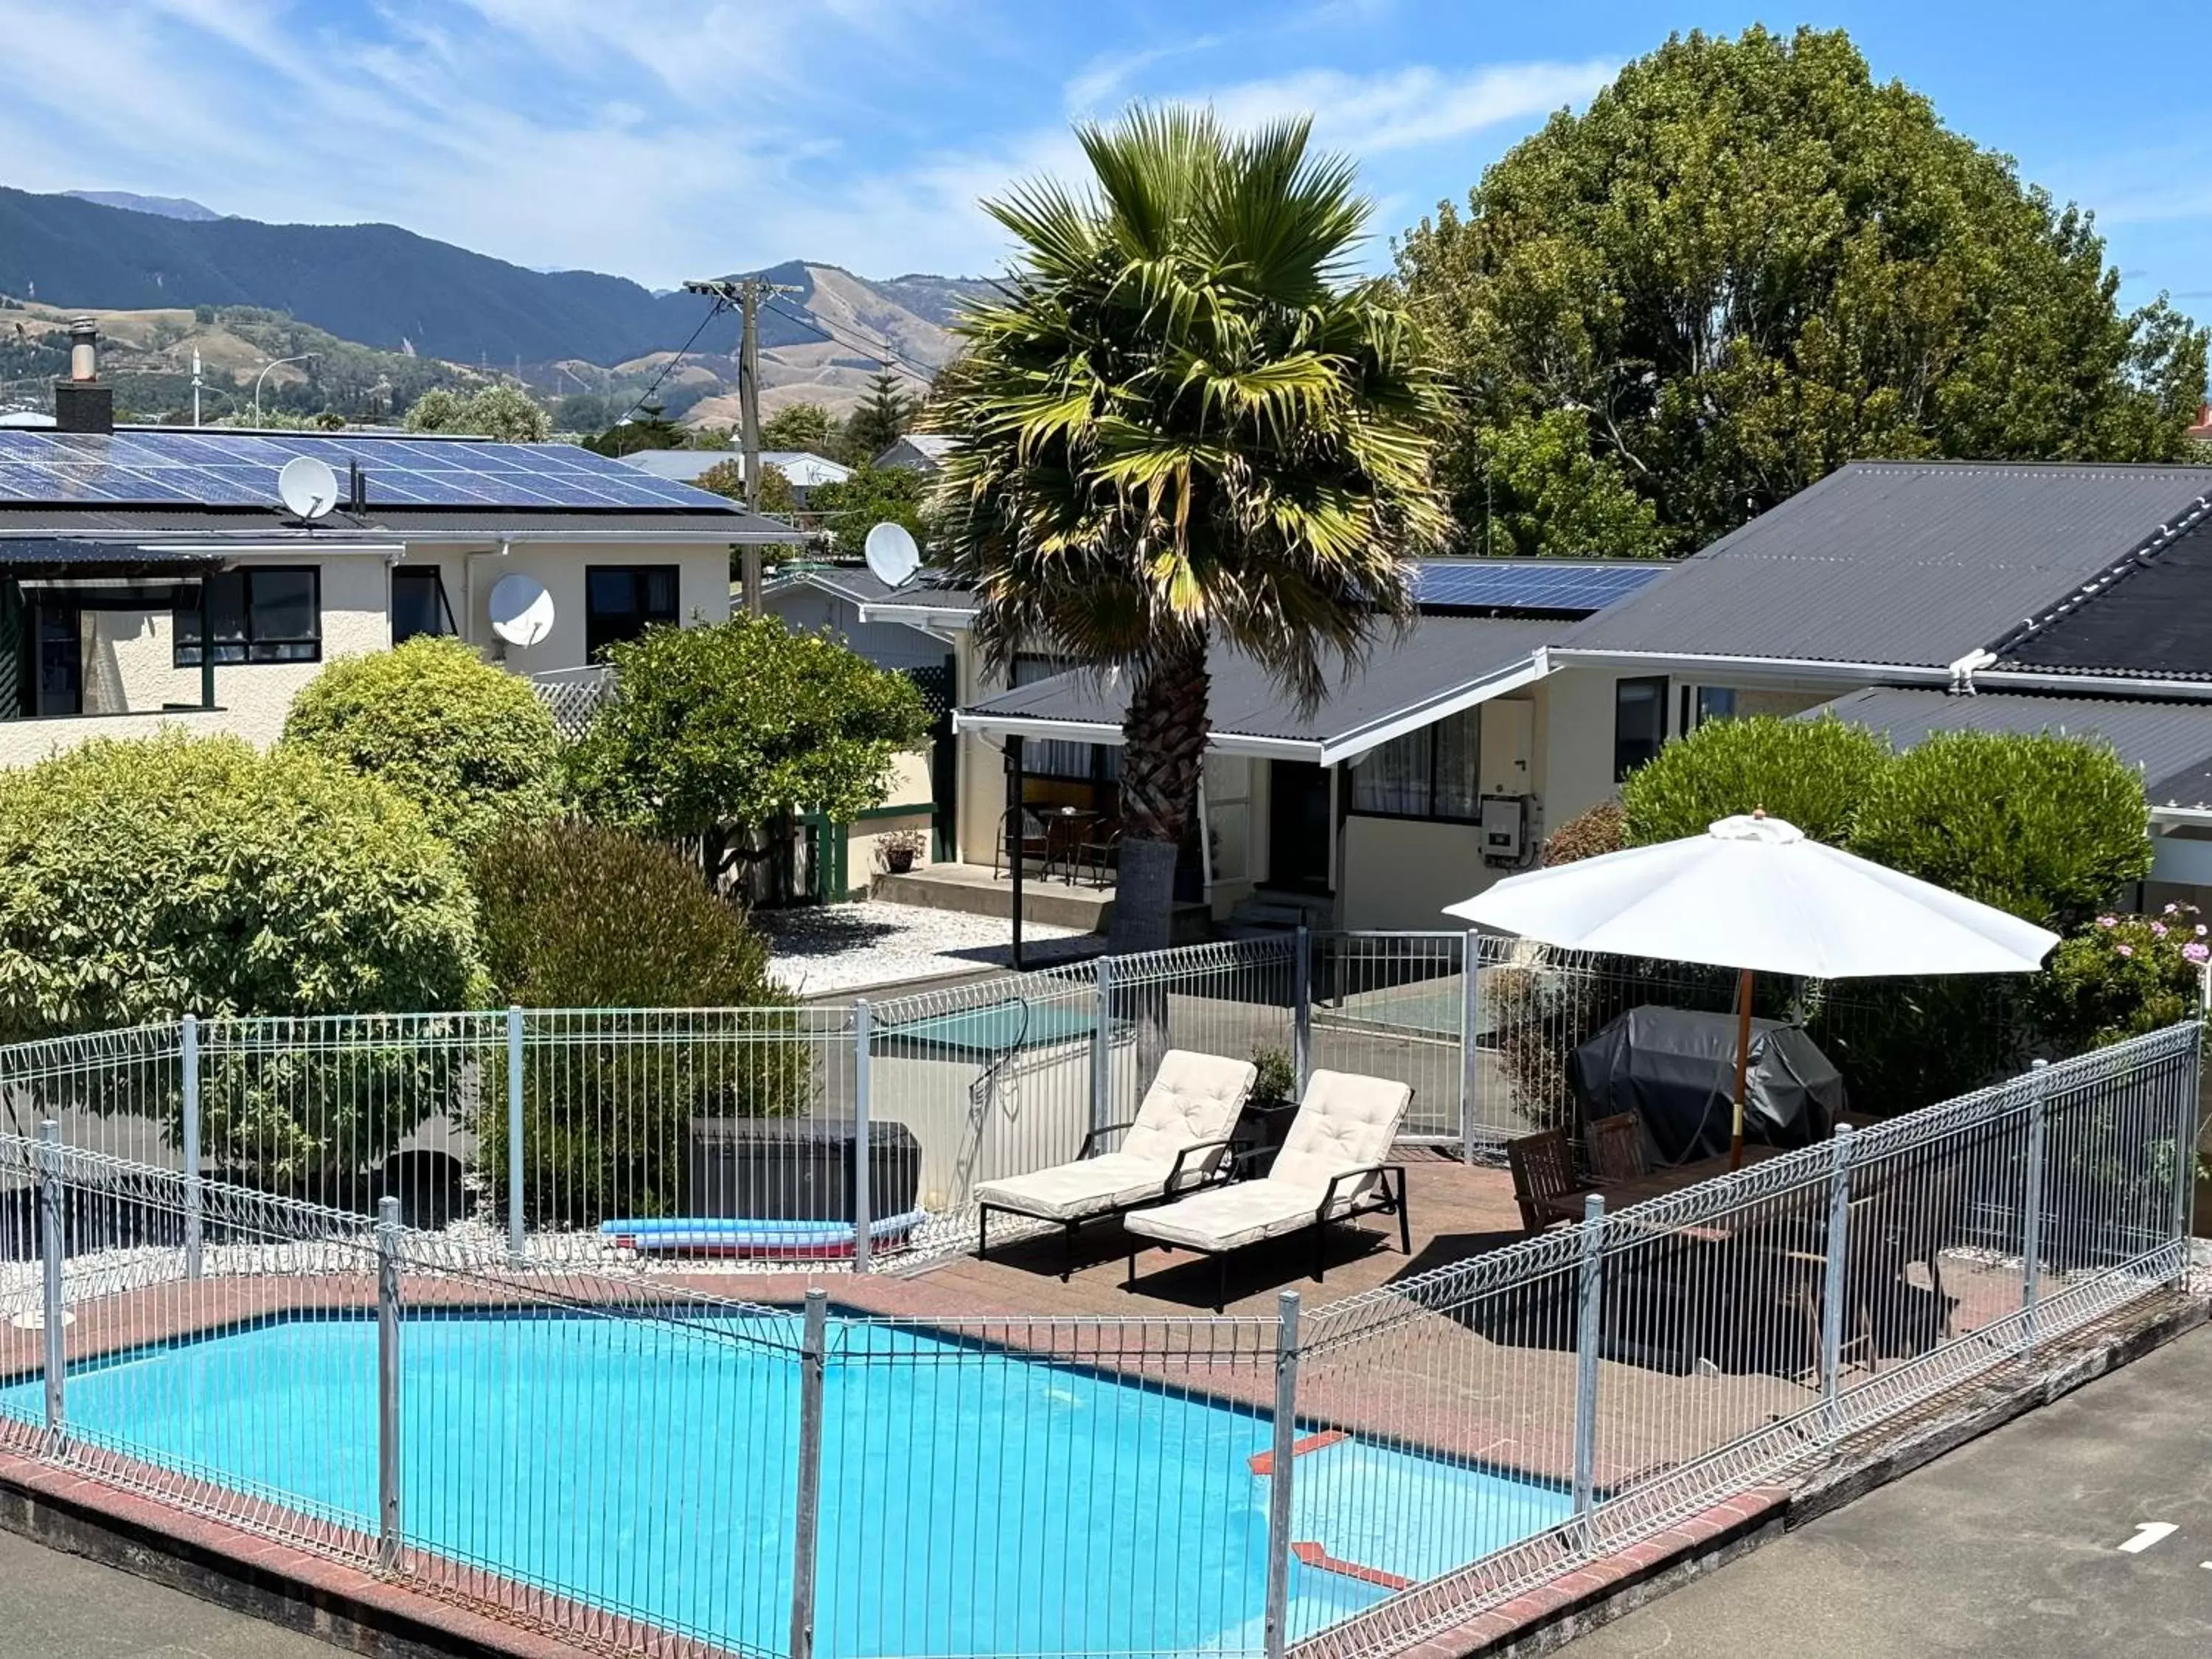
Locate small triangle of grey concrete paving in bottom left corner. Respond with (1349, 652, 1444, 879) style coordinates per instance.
(0, 1533, 338, 1659)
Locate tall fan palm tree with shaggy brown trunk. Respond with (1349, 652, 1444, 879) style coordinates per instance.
(929, 106, 1447, 951)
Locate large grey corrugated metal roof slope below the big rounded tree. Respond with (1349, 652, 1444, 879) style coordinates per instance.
(1559, 460, 2212, 668)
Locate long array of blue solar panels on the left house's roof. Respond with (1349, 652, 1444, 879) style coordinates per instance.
(0, 429, 728, 511)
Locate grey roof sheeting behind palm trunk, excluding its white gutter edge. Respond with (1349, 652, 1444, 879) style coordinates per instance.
(964, 617, 1559, 761)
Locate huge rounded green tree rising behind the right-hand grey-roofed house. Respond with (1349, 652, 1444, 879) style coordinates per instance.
(1398, 27, 2205, 553)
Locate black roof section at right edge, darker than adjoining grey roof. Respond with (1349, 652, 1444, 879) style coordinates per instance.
(1995, 513, 2212, 679)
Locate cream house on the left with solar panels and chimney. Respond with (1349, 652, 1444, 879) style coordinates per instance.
(0, 354, 799, 765)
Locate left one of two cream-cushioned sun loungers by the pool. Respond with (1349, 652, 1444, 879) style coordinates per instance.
(975, 1048, 1259, 1279)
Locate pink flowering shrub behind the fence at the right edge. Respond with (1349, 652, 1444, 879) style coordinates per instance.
(2037, 905, 2212, 1053)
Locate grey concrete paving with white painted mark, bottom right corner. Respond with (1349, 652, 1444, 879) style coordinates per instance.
(1564, 1327, 2212, 1659)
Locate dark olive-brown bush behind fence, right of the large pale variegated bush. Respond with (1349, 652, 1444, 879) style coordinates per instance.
(476, 823, 814, 1228)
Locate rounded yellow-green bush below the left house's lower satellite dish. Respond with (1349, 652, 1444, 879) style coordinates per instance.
(283, 635, 560, 847)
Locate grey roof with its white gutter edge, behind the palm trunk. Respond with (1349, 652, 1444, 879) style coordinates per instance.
(956, 617, 1559, 765)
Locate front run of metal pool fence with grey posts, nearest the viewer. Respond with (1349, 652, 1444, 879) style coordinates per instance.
(0, 1024, 2201, 1659)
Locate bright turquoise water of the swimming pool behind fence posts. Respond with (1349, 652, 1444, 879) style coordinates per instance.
(13, 1310, 1568, 1657)
